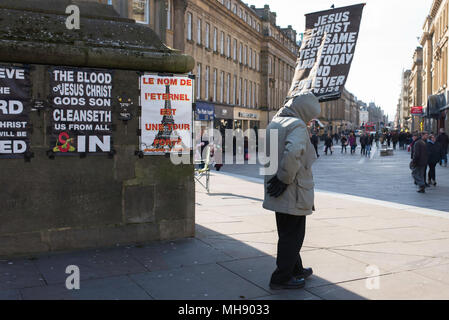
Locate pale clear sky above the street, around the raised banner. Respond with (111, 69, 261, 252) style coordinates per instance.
(252, 0, 432, 121)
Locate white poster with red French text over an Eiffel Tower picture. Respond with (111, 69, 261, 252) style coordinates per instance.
(140, 75, 193, 155)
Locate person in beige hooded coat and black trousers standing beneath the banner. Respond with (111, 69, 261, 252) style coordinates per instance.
(263, 93, 321, 290)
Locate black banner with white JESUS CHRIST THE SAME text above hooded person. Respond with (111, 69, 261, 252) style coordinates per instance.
(288, 4, 365, 101)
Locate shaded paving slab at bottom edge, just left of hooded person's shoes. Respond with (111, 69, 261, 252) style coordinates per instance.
(130, 264, 267, 300)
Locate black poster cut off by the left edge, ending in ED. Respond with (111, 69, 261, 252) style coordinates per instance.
(0, 65, 31, 158)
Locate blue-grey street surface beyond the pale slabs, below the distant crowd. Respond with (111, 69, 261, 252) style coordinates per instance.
(221, 144, 449, 211)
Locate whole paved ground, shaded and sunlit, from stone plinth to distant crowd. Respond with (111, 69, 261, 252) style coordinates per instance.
(0, 152, 449, 300)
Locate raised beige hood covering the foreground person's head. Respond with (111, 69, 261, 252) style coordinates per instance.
(275, 92, 321, 123)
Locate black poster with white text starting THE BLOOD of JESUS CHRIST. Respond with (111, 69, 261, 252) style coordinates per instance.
(50, 67, 113, 155)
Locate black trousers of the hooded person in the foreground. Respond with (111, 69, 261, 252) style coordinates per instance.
(271, 212, 306, 283)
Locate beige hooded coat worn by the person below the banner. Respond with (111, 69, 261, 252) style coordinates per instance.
(263, 93, 321, 216)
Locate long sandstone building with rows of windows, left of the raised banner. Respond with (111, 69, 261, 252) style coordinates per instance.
(100, 0, 299, 130)
